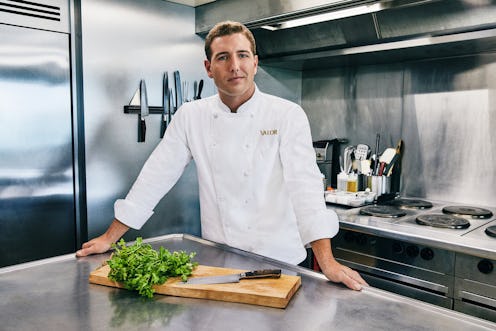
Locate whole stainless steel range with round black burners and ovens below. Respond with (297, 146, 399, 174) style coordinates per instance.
(332, 199, 496, 321)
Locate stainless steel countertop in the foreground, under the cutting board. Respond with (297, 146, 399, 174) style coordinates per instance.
(0, 235, 496, 331)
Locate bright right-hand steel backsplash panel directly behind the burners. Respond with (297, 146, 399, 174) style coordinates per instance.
(403, 54, 496, 205)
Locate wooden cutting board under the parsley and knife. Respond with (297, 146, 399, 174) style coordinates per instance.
(89, 265, 301, 308)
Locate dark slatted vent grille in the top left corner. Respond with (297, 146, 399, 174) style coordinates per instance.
(0, 0, 60, 22)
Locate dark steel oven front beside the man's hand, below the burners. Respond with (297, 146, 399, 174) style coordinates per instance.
(332, 230, 455, 308)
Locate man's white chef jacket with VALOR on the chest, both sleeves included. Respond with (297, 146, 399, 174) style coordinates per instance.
(114, 88, 339, 264)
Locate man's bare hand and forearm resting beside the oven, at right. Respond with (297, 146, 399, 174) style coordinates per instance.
(311, 239, 368, 291)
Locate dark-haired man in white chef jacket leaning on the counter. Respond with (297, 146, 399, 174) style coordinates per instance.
(76, 21, 366, 290)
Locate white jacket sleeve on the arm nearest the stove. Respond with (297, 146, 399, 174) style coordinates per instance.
(280, 105, 339, 245)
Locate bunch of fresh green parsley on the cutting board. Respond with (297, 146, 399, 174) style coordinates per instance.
(107, 237, 198, 298)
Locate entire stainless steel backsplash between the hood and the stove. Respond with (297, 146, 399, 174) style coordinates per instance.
(302, 53, 496, 206)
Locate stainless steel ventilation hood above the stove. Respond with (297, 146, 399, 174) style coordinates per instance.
(196, 0, 496, 70)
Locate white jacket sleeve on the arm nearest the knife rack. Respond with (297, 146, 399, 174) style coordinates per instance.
(114, 106, 192, 229)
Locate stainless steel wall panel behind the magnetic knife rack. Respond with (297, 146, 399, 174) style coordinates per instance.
(81, 0, 214, 239)
